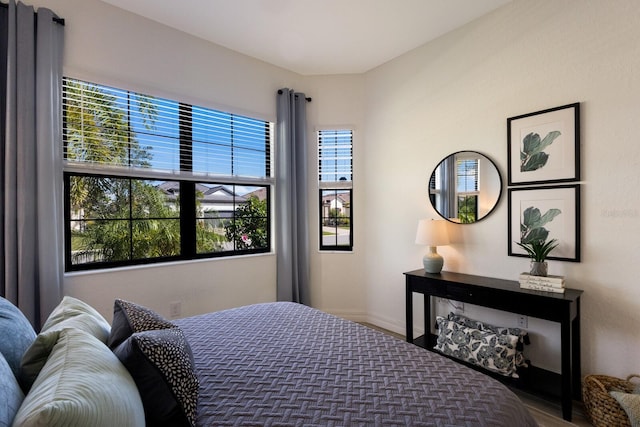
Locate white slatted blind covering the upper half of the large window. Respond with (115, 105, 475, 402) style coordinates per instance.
(63, 78, 273, 181)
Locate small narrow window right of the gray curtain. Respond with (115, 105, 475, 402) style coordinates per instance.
(318, 130, 353, 251)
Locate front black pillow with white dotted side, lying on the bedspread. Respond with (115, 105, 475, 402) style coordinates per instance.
(114, 327, 199, 427)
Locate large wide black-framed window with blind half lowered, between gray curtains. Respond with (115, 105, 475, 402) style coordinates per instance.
(63, 78, 273, 271)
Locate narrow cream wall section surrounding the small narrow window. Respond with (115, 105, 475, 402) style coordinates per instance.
(304, 75, 370, 321)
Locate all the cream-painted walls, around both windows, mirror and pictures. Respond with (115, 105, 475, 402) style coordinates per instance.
(31, 0, 640, 382)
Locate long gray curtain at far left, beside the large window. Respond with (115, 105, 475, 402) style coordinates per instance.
(0, 0, 64, 329)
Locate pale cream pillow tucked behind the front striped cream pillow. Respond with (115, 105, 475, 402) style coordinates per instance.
(18, 296, 111, 392)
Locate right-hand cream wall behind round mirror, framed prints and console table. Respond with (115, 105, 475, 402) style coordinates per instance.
(364, 0, 640, 376)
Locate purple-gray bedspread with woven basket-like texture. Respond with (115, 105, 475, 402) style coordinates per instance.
(175, 303, 536, 427)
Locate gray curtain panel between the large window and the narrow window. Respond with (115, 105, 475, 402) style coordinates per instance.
(275, 89, 310, 305)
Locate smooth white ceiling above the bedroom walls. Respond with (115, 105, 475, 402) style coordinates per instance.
(102, 0, 511, 75)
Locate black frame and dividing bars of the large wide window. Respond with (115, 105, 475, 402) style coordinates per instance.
(62, 77, 274, 272)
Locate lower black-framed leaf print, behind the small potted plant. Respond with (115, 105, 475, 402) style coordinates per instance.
(507, 184, 580, 262)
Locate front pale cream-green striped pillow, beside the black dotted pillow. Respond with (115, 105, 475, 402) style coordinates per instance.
(14, 329, 145, 427)
